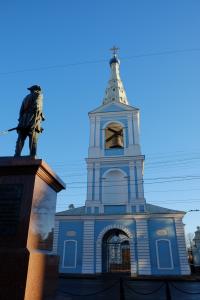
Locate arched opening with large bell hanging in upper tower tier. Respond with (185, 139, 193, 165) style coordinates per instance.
(105, 123, 124, 149)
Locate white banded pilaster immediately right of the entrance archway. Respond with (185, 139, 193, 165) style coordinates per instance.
(136, 219, 151, 275)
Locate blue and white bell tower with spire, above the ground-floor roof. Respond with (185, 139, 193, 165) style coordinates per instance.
(86, 47, 145, 214)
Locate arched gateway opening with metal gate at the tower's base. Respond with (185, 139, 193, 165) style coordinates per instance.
(102, 229, 131, 273)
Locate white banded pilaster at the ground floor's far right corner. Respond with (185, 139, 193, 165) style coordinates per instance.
(175, 218, 190, 275)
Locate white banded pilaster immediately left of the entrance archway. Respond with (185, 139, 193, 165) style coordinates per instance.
(82, 221, 94, 274)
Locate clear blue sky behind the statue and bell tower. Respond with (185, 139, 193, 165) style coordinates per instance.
(0, 0, 200, 232)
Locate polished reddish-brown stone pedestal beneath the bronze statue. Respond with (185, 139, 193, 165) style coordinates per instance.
(0, 157, 65, 300)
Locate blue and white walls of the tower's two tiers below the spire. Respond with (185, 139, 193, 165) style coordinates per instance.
(86, 103, 145, 213)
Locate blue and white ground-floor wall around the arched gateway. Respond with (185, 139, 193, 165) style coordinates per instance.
(55, 215, 190, 275)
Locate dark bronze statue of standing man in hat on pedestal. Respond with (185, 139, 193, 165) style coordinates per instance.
(15, 85, 44, 157)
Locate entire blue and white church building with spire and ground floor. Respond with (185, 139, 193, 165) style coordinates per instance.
(53, 49, 190, 276)
